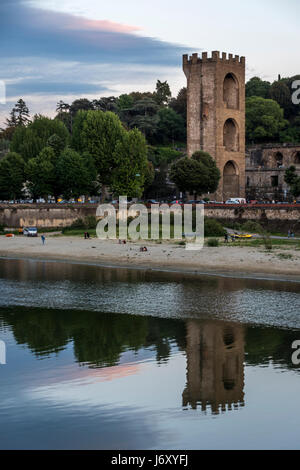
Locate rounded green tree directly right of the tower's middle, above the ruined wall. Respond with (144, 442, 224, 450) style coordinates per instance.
(246, 96, 288, 142)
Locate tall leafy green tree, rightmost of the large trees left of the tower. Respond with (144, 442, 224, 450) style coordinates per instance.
(111, 129, 148, 197)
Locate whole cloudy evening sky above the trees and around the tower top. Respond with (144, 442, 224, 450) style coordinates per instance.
(0, 0, 300, 125)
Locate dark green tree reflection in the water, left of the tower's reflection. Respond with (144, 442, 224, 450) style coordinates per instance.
(0, 307, 185, 367)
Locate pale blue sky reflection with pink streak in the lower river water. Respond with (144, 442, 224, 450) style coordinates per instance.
(0, 324, 300, 449)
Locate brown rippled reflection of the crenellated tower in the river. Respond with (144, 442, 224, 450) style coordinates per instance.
(182, 320, 244, 414)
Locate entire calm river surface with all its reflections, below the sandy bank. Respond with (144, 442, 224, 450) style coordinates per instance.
(0, 260, 300, 449)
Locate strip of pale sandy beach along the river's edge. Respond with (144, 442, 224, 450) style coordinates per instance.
(0, 234, 300, 280)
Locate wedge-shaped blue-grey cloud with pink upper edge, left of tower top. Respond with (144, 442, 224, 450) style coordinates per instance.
(0, 0, 185, 65)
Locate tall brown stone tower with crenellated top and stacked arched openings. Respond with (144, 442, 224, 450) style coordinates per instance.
(183, 51, 246, 201)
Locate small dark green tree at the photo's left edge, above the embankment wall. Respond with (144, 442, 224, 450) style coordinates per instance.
(0, 152, 25, 200)
